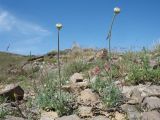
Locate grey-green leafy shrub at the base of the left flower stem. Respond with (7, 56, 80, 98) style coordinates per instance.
(36, 72, 74, 116)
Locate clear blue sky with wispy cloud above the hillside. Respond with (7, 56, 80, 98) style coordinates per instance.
(0, 0, 160, 54)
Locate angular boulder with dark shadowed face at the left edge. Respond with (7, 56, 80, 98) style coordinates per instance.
(0, 84, 24, 101)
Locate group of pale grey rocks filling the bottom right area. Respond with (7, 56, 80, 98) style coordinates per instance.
(121, 85, 160, 120)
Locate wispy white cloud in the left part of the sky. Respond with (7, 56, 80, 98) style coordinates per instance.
(0, 9, 51, 54)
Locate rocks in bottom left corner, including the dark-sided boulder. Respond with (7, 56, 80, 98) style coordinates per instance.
(0, 84, 39, 120)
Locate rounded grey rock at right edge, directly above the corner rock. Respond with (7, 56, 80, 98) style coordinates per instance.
(142, 97, 160, 110)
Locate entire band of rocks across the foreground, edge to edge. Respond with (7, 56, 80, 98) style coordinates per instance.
(0, 73, 160, 120)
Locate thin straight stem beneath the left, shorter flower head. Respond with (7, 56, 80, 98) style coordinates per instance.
(58, 30, 62, 96)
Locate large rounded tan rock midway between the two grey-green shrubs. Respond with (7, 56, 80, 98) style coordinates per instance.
(77, 89, 99, 106)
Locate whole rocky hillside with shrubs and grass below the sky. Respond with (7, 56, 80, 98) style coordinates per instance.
(0, 47, 160, 120)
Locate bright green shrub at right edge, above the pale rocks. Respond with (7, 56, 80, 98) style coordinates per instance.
(126, 49, 160, 84)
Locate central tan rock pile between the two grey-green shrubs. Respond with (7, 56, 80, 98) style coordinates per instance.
(41, 73, 125, 120)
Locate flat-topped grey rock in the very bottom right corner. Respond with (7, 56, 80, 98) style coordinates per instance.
(142, 111, 160, 120)
